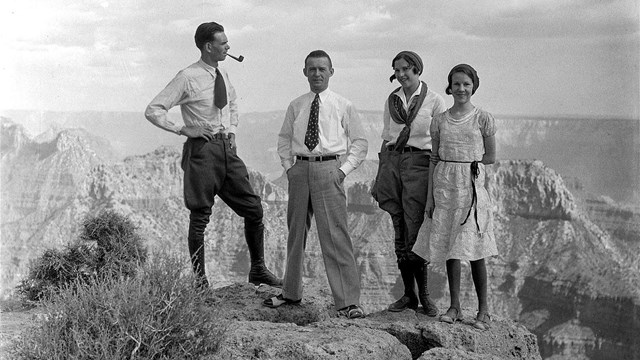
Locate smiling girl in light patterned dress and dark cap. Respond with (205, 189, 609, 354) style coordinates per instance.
(422, 64, 498, 330)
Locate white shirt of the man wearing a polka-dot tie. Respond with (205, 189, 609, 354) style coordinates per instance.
(278, 89, 368, 175)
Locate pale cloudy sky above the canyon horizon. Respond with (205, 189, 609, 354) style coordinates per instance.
(0, 0, 640, 119)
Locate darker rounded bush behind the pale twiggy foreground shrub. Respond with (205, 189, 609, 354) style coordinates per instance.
(17, 210, 147, 301)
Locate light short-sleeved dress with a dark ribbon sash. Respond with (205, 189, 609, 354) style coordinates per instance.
(413, 108, 498, 267)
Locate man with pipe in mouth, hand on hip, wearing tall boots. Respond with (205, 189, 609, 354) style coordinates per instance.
(145, 22, 282, 287)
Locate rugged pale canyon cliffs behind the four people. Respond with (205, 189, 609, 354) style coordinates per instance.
(0, 119, 640, 359)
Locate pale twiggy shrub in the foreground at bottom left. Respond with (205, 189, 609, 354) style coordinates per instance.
(12, 255, 227, 360)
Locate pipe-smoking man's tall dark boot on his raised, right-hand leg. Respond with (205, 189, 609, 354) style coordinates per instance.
(244, 221, 282, 287)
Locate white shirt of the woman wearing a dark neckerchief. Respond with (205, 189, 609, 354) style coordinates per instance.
(382, 82, 446, 150)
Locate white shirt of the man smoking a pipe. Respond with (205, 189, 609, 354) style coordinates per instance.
(145, 59, 238, 134)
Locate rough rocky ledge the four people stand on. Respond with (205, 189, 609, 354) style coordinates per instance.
(205, 283, 541, 360)
